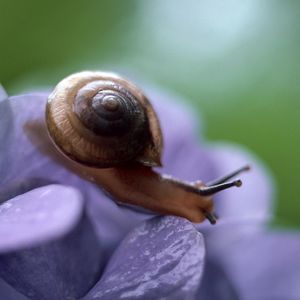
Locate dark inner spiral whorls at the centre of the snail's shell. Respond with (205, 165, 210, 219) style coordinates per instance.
(71, 80, 148, 137)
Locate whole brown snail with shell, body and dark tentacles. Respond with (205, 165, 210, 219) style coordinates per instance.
(46, 71, 249, 224)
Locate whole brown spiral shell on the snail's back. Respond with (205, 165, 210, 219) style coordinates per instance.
(46, 71, 162, 167)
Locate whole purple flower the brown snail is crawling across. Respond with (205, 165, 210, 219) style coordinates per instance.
(0, 82, 300, 300)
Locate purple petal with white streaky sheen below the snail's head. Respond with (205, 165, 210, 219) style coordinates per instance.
(85, 216, 205, 300)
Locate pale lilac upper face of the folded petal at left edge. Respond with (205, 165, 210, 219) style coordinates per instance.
(0, 185, 83, 253)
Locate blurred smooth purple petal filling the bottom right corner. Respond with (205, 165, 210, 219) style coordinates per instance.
(218, 232, 300, 300)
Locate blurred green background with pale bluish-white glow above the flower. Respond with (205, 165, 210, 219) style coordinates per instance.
(0, 0, 300, 226)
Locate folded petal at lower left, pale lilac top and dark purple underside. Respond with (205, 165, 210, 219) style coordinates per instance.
(0, 185, 102, 300)
